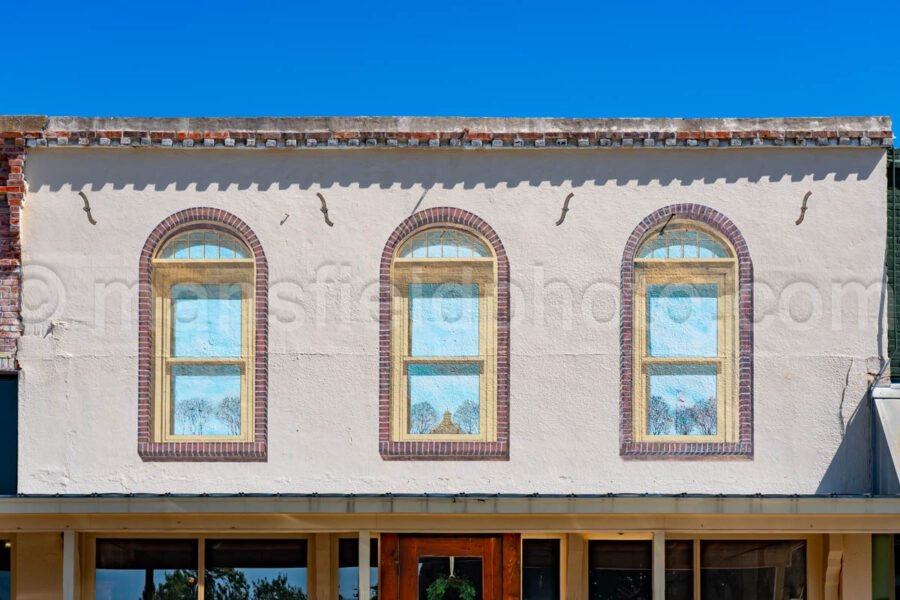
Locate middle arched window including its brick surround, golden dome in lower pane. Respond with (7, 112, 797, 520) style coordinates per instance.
(382, 209, 508, 458)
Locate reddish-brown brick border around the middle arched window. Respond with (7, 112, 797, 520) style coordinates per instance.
(378, 207, 510, 460)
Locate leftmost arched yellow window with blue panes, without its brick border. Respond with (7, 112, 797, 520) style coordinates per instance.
(153, 227, 255, 442)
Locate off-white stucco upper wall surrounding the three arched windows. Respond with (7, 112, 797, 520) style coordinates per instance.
(19, 148, 885, 493)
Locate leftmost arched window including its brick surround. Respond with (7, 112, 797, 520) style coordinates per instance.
(139, 209, 266, 460)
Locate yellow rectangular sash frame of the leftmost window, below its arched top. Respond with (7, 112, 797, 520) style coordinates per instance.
(151, 259, 256, 442)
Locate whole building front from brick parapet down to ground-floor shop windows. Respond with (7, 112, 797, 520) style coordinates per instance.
(0, 117, 900, 600)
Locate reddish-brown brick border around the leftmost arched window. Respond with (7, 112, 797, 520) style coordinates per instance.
(138, 207, 269, 461)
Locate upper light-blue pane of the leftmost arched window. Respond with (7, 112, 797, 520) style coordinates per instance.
(171, 284, 241, 358)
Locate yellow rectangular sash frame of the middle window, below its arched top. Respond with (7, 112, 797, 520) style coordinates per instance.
(390, 248, 497, 442)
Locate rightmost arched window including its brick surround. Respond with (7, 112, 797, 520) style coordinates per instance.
(623, 210, 750, 454)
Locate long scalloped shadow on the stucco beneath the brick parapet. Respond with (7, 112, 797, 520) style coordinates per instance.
(26, 149, 884, 191)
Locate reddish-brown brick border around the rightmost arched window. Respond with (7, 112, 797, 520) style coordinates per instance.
(619, 204, 753, 458)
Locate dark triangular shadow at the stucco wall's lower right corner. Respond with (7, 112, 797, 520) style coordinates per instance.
(816, 391, 872, 494)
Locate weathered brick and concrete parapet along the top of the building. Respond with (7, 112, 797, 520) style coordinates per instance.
(0, 115, 893, 149)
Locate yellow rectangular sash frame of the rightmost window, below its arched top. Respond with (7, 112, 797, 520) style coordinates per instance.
(632, 258, 740, 442)
